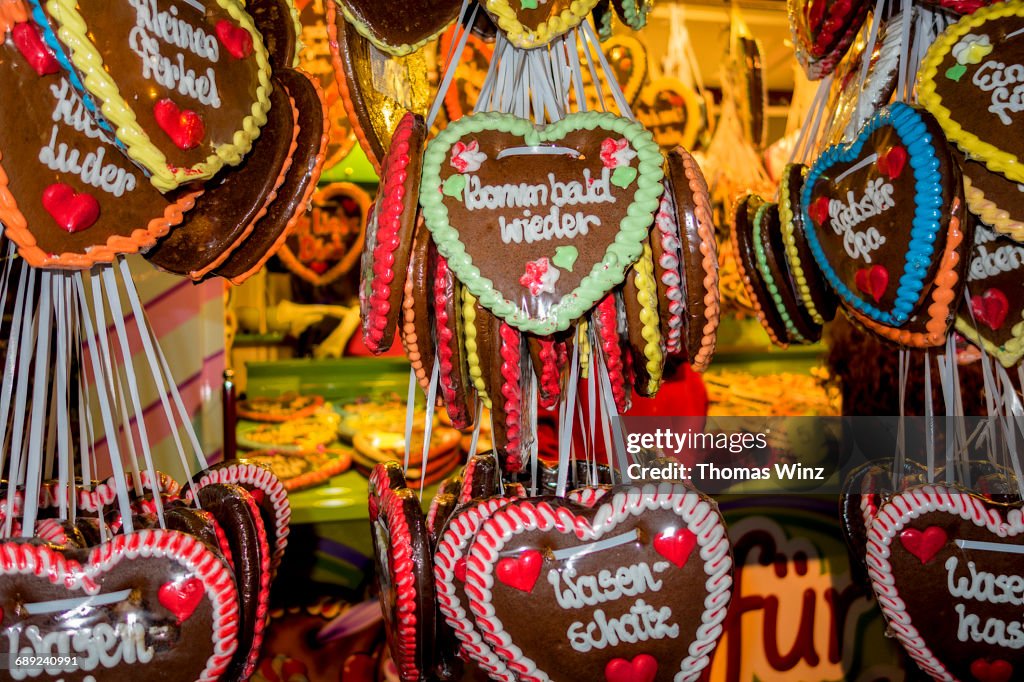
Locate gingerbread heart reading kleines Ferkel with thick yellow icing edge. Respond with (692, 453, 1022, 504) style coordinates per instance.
(32, 0, 272, 191)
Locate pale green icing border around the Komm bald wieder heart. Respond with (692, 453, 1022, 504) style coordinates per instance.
(420, 112, 665, 336)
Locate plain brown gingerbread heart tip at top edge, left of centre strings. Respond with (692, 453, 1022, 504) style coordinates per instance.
(338, 0, 462, 56)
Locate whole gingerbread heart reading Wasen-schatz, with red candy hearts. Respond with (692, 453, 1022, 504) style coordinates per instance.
(466, 483, 732, 682)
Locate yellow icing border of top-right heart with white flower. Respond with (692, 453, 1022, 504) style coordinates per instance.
(918, 2, 1024, 182)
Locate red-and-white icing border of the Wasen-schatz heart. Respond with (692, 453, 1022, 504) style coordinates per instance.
(466, 482, 732, 682)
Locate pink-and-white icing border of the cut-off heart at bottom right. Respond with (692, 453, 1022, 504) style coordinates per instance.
(867, 485, 1024, 682)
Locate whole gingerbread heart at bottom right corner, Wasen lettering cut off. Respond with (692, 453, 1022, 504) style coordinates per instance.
(867, 485, 1024, 680)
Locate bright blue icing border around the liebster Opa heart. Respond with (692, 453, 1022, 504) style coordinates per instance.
(800, 102, 942, 327)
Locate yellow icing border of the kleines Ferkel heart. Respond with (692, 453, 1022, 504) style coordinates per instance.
(46, 0, 273, 191)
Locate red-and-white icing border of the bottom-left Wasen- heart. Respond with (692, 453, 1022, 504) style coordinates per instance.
(0, 529, 239, 682)
